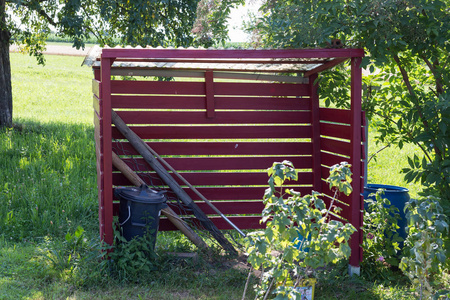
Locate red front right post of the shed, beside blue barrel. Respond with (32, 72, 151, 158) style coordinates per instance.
(350, 57, 363, 274)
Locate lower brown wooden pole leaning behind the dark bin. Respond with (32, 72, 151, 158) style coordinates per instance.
(112, 152, 208, 249)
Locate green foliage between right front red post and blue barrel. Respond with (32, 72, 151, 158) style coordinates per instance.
(363, 190, 403, 268)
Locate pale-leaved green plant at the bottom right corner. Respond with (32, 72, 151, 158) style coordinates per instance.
(400, 197, 448, 299)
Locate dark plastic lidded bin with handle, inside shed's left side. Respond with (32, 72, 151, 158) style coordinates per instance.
(114, 184, 167, 245)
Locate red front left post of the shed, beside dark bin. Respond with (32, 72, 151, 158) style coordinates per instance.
(99, 58, 113, 245)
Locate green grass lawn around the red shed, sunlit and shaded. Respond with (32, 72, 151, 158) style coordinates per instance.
(0, 53, 442, 299)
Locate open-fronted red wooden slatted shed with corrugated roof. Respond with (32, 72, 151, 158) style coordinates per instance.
(93, 48, 364, 267)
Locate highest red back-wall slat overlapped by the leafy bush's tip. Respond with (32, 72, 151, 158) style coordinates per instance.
(119, 156, 312, 171)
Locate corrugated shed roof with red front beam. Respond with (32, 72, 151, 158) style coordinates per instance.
(83, 46, 364, 77)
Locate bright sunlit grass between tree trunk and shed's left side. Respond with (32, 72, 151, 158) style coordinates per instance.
(10, 53, 93, 124)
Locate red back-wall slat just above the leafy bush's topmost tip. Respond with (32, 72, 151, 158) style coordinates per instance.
(112, 141, 312, 155)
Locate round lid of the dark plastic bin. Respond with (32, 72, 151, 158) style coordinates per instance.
(114, 184, 166, 204)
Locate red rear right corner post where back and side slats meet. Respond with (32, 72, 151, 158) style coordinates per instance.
(309, 73, 322, 193)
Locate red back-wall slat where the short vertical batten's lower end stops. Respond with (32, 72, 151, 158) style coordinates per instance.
(117, 111, 311, 125)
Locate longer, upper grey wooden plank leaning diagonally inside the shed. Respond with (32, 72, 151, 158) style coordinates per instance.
(111, 110, 237, 254)
